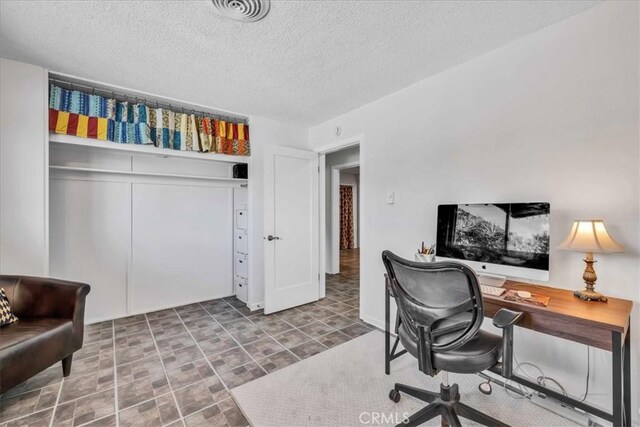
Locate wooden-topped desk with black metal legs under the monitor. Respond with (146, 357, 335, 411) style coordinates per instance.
(385, 281, 633, 426)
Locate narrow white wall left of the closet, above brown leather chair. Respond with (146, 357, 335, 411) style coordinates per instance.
(0, 58, 48, 276)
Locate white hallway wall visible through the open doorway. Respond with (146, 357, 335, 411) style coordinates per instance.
(319, 144, 360, 274)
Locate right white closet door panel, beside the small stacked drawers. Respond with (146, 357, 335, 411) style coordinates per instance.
(131, 184, 233, 313)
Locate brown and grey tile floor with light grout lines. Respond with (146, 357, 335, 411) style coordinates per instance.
(0, 249, 364, 427)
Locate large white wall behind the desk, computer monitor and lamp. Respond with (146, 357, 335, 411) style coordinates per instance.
(309, 2, 640, 421)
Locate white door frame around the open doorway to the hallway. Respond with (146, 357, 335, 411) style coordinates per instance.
(313, 134, 365, 300)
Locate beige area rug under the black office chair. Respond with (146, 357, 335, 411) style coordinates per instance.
(232, 331, 576, 427)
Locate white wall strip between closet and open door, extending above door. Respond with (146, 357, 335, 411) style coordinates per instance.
(249, 117, 309, 309)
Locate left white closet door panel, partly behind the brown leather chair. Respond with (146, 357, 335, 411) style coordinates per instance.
(49, 179, 131, 323)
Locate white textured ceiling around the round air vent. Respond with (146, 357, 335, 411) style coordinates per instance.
(0, 1, 595, 125)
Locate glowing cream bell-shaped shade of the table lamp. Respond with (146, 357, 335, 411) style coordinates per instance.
(558, 219, 624, 252)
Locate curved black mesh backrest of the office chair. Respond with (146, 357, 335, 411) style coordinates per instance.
(382, 251, 483, 352)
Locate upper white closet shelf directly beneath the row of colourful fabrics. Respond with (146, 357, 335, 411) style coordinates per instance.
(49, 133, 250, 164)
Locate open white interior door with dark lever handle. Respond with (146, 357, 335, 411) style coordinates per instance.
(264, 146, 319, 314)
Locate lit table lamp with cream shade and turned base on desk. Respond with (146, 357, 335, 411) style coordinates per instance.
(558, 219, 624, 302)
